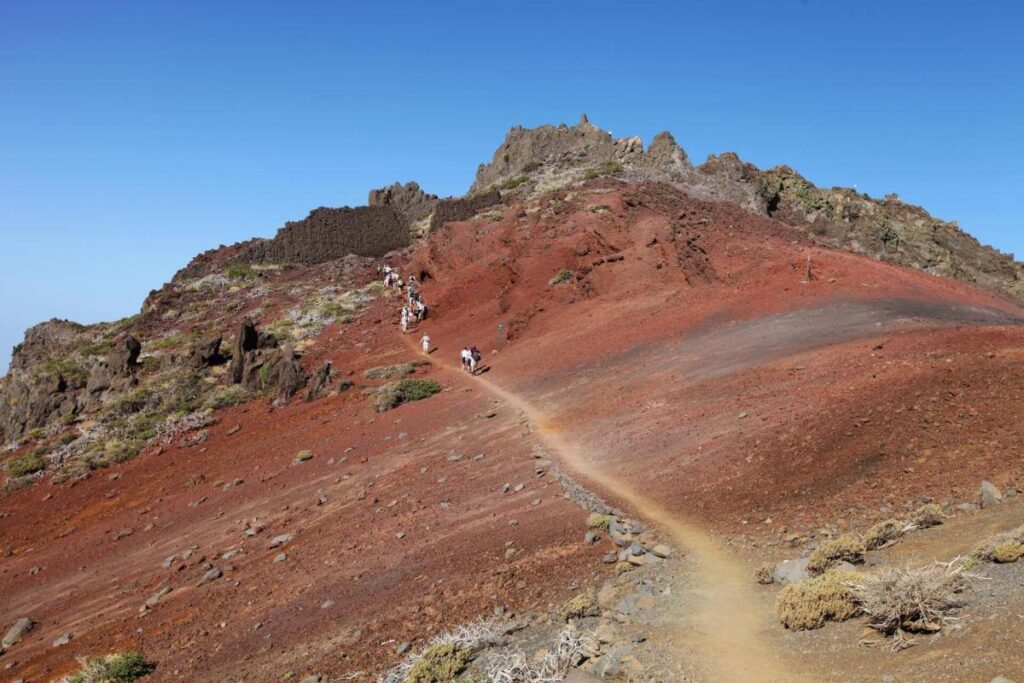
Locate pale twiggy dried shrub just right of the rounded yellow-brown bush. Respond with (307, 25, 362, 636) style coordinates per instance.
(853, 562, 965, 650)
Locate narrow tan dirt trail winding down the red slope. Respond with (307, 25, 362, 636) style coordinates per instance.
(409, 340, 798, 682)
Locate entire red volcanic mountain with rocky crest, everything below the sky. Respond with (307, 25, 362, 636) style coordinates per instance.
(0, 117, 1024, 683)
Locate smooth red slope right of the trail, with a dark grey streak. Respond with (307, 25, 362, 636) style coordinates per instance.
(407, 181, 1024, 533)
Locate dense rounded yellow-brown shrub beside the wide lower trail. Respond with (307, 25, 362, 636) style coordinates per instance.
(775, 570, 863, 631)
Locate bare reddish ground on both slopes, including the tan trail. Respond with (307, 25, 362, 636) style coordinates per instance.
(0, 180, 1024, 681)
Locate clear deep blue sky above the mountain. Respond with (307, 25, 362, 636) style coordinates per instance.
(0, 0, 1024, 372)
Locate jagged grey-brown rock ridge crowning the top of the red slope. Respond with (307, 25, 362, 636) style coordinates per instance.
(471, 116, 1024, 297)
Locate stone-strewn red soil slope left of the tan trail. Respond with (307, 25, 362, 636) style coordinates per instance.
(0, 300, 604, 681)
